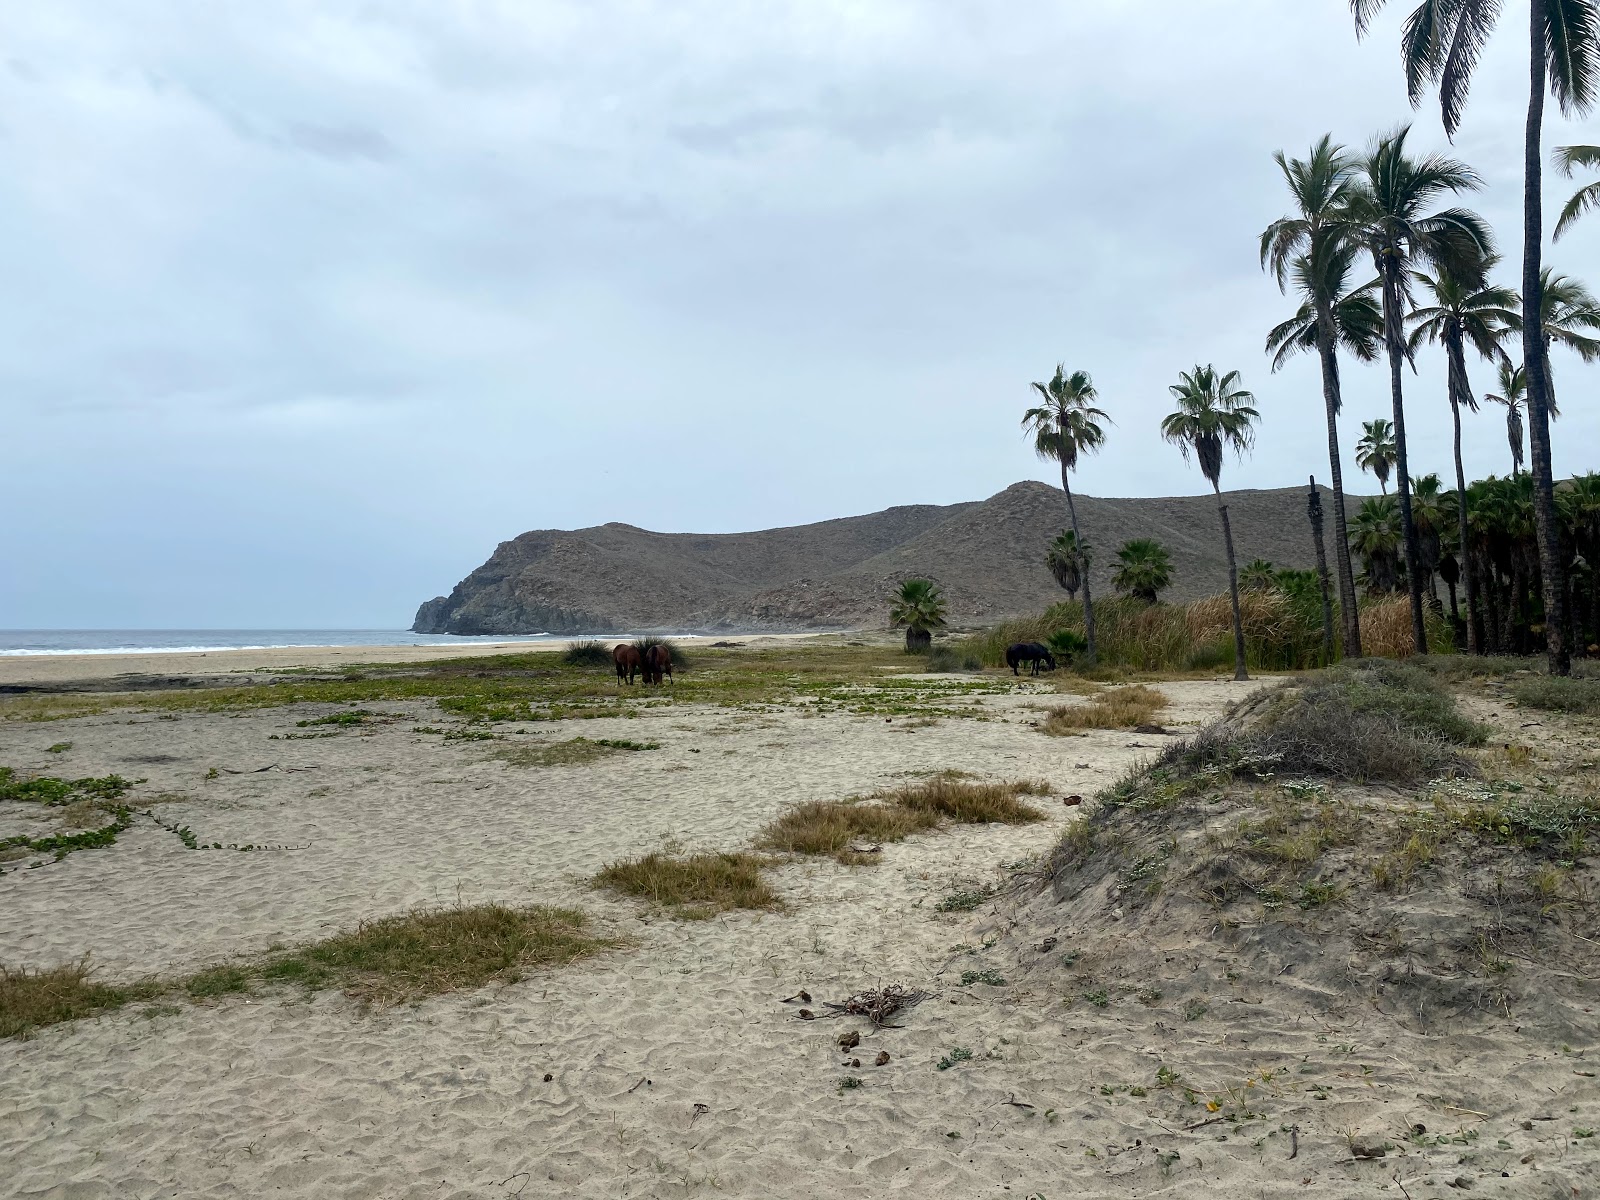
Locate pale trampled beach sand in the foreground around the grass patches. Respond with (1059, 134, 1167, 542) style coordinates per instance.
(0, 662, 1597, 1200)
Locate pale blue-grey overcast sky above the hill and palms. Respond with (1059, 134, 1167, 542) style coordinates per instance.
(0, 0, 1600, 629)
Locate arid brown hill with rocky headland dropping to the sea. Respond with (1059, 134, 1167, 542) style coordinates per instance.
(413, 482, 1350, 634)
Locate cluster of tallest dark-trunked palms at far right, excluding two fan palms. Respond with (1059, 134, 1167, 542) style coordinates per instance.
(1261, 0, 1600, 675)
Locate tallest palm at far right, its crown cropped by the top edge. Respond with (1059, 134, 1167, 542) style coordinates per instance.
(1350, 0, 1600, 675)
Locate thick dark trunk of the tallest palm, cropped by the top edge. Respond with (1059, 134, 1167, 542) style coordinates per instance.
(1522, 0, 1573, 675)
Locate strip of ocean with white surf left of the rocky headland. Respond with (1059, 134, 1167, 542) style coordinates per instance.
(0, 629, 569, 654)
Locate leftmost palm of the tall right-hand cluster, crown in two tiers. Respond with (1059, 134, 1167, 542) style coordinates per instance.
(1261, 134, 1376, 658)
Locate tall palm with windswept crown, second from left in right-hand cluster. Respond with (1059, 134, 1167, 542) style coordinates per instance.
(1346, 128, 1491, 654)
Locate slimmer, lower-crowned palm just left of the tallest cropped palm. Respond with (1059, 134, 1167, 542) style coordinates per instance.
(1410, 256, 1520, 654)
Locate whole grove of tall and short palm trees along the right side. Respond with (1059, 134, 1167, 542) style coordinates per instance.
(896, 0, 1600, 678)
